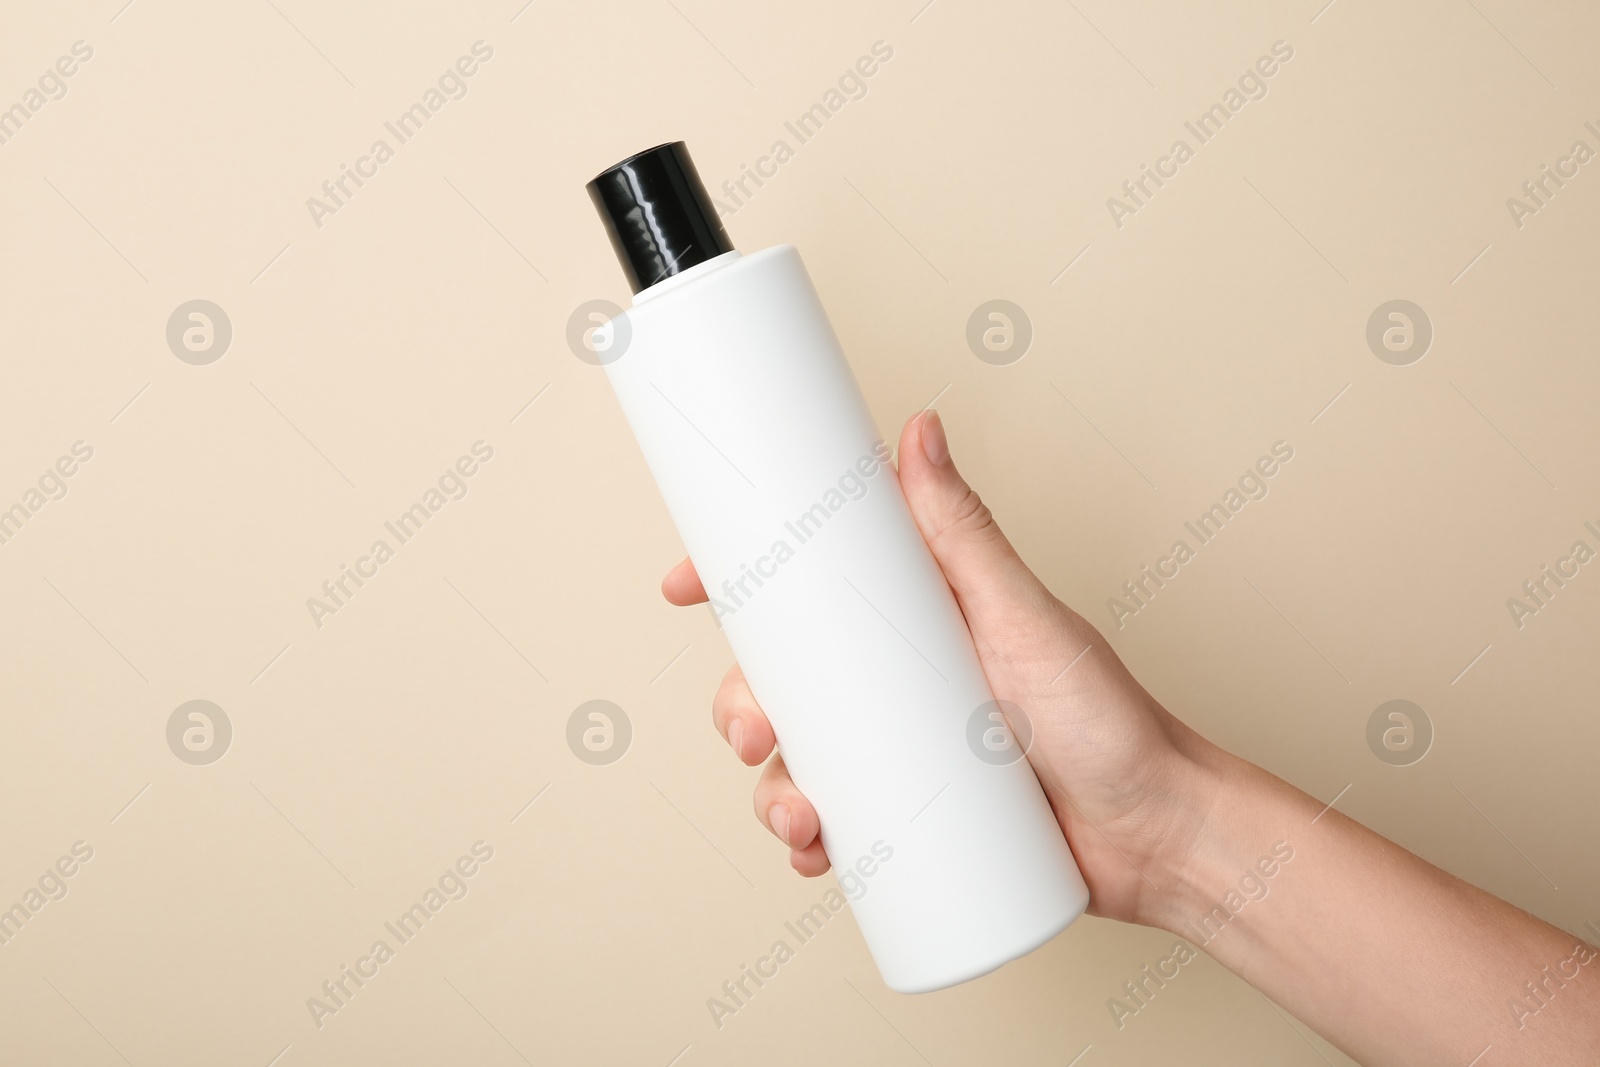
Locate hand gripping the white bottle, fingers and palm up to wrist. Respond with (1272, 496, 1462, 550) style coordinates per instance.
(661, 413, 1230, 921)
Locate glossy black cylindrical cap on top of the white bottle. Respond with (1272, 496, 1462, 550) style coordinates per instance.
(587, 141, 733, 293)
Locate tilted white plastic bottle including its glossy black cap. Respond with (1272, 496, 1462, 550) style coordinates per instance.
(589, 142, 1088, 993)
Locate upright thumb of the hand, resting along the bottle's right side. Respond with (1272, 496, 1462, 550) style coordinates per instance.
(899, 411, 1056, 648)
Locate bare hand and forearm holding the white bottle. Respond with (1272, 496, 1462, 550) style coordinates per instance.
(662, 411, 1600, 1067)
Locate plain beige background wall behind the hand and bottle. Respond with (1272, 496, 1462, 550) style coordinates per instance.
(0, 0, 1600, 1067)
